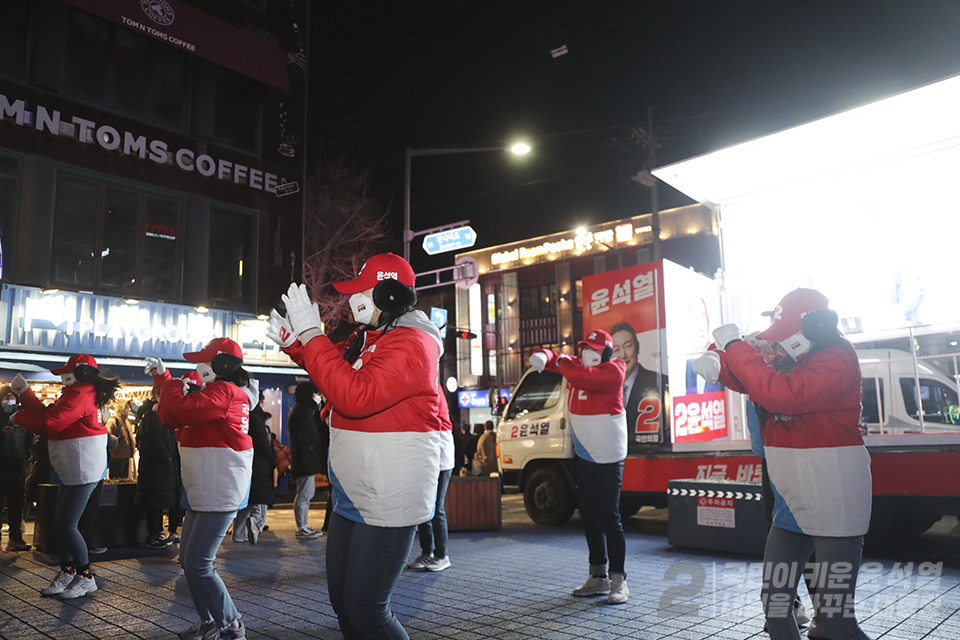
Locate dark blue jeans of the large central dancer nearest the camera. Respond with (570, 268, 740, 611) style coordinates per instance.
(327, 513, 417, 640)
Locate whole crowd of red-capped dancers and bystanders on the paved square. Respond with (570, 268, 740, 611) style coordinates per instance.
(0, 253, 870, 640)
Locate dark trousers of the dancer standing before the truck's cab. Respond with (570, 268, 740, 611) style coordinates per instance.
(577, 457, 627, 576)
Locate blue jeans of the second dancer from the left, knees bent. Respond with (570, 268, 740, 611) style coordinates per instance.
(180, 510, 240, 629)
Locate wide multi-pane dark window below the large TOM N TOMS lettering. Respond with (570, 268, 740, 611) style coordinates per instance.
(53, 173, 181, 301)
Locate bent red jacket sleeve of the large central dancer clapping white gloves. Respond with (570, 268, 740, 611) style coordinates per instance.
(300, 329, 439, 419)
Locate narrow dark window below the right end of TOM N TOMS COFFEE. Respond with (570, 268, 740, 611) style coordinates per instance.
(207, 207, 255, 309)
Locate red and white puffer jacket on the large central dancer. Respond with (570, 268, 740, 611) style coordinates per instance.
(284, 311, 453, 527)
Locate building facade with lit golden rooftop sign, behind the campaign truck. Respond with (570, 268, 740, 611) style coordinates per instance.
(457, 205, 720, 422)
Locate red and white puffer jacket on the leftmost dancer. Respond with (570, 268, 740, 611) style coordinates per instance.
(15, 382, 107, 486)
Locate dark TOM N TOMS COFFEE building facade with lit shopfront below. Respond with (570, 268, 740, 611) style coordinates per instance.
(0, 0, 308, 416)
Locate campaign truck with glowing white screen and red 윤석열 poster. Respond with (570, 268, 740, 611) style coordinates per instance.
(498, 77, 960, 543)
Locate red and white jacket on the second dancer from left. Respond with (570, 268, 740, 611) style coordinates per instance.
(154, 372, 253, 512)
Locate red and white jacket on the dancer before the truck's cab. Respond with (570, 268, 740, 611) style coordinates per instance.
(539, 349, 627, 464)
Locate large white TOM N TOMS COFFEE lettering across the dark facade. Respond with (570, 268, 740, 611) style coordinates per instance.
(0, 93, 299, 196)
